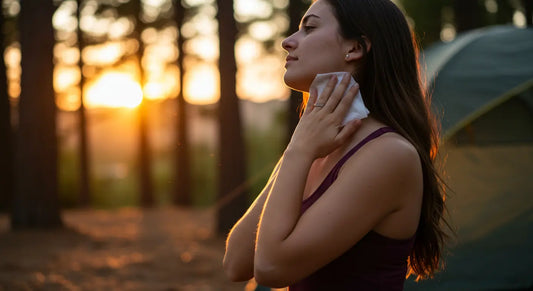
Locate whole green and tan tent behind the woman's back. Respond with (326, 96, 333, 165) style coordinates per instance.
(405, 26, 533, 290)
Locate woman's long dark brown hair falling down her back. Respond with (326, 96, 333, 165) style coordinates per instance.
(326, 0, 448, 279)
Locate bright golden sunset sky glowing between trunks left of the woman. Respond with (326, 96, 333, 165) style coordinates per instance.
(4, 0, 288, 111)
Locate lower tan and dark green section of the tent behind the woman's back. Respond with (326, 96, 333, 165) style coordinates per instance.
(405, 144, 533, 291)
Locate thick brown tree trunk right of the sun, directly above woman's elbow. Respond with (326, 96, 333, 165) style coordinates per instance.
(217, 0, 249, 235)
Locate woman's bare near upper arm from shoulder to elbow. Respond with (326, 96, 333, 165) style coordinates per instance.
(258, 137, 421, 281)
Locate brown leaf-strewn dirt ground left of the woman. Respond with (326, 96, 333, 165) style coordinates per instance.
(0, 208, 251, 291)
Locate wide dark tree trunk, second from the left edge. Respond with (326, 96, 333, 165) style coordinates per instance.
(11, 0, 62, 229)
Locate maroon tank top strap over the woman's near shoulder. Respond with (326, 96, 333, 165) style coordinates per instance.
(301, 126, 396, 213)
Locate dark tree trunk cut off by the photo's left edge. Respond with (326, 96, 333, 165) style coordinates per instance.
(0, 6, 14, 211)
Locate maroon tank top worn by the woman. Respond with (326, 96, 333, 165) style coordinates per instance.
(289, 127, 415, 291)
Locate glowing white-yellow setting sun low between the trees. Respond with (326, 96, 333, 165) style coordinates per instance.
(85, 72, 143, 108)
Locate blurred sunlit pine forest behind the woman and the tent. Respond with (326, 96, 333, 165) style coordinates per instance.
(0, 0, 532, 290)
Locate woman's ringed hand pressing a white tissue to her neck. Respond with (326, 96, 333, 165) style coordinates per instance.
(287, 73, 360, 159)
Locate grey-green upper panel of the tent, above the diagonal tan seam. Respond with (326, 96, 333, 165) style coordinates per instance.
(422, 26, 533, 138)
